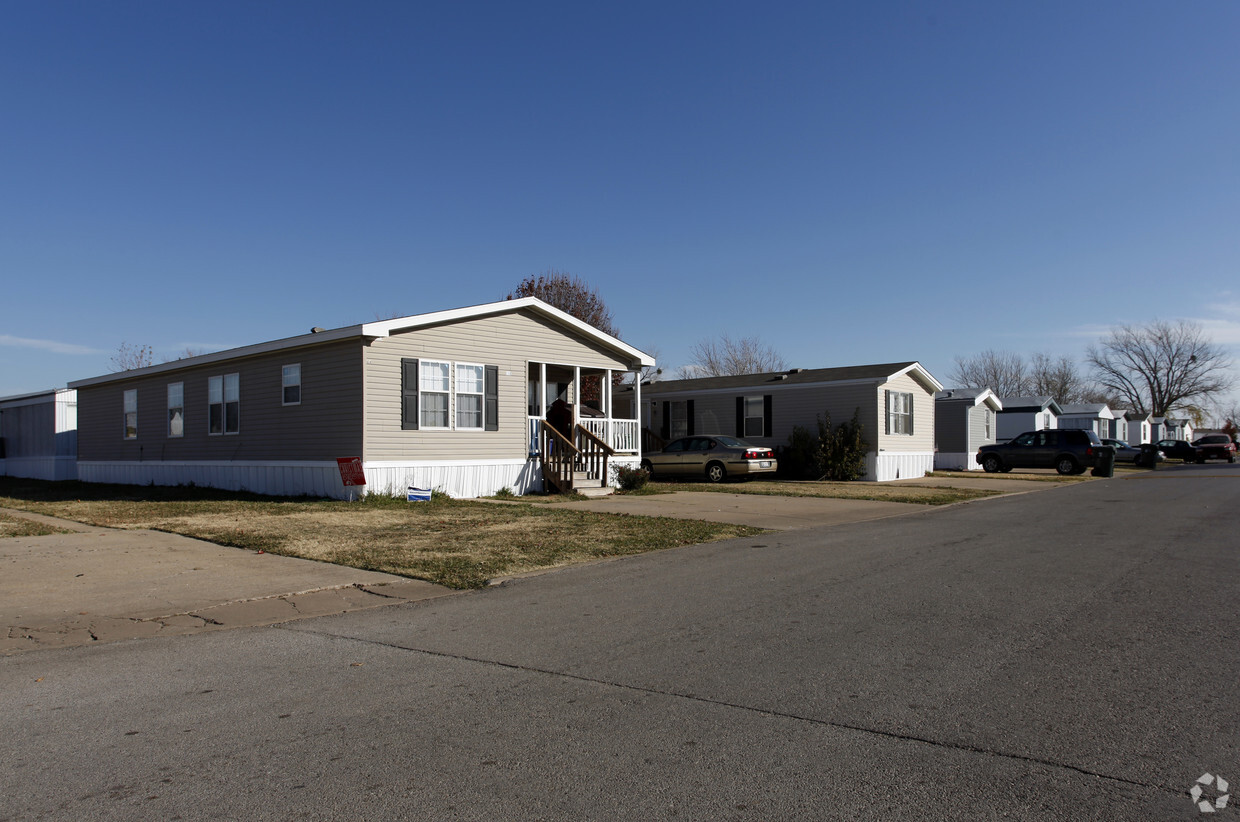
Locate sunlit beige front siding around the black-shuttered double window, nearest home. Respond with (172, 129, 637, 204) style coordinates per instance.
(365, 311, 629, 461)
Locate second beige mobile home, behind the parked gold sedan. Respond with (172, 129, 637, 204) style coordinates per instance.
(639, 362, 942, 481)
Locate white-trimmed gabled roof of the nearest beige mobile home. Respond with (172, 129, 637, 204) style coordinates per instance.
(69, 296, 655, 388)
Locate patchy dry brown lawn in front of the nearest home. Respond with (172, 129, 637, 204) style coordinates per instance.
(0, 479, 760, 588)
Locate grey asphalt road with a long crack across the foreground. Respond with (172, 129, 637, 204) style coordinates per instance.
(0, 464, 1240, 822)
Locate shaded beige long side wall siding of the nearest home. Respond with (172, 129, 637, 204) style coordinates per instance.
(78, 340, 362, 461)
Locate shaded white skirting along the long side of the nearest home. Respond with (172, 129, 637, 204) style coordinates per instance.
(78, 461, 348, 500)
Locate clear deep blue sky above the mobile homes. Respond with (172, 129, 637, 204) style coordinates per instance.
(0, 0, 1240, 404)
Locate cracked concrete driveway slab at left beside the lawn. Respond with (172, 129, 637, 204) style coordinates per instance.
(0, 510, 454, 655)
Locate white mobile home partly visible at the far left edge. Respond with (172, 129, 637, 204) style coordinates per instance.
(0, 388, 77, 480)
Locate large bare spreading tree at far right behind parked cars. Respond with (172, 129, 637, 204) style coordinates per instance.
(1086, 320, 1235, 417)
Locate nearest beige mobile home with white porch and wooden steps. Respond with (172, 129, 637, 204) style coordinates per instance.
(72, 298, 653, 497)
